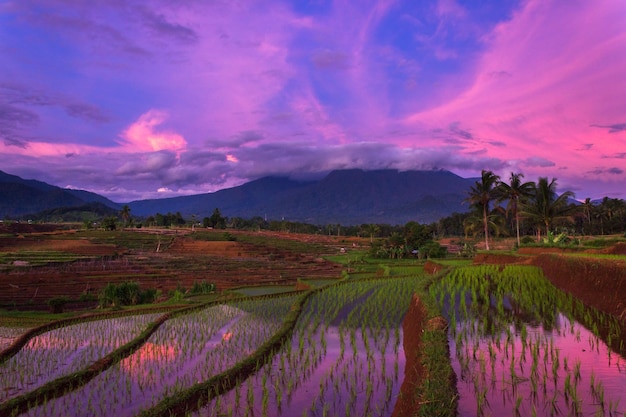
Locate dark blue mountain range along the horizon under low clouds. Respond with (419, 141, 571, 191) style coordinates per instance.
(0, 169, 476, 225)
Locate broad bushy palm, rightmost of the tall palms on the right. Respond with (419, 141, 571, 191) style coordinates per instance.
(521, 177, 574, 239)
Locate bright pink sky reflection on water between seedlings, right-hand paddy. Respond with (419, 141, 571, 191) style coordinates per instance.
(450, 314, 626, 417)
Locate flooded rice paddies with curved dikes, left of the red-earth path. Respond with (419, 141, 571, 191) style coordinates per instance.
(0, 277, 424, 416)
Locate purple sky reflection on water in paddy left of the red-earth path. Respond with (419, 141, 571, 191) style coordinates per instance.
(199, 326, 405, 417)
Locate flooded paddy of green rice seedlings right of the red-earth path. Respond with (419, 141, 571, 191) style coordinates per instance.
(431, 265, 626, 416)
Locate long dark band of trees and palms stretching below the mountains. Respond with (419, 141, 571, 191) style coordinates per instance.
(90, 170, 626, 257)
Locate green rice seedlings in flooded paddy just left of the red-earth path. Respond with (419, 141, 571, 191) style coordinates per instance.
(194, 278, 415, 416)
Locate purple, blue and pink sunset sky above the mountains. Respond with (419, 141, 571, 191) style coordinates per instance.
(0, 0, 626, 202)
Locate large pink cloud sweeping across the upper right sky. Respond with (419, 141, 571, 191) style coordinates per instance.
(402, 0, 626, 196)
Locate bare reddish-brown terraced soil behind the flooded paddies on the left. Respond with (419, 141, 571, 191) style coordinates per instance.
(0, 229, 342, 309)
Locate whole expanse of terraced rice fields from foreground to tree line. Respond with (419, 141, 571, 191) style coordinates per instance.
(0, 226, 626, 417)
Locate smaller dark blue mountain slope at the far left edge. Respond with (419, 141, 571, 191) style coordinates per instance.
(0, 171, 121, 219)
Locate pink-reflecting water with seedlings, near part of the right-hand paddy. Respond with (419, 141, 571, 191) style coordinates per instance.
(449, 290, 626, 416)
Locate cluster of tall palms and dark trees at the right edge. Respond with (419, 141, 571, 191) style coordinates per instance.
(458, 170, 626, 249)
